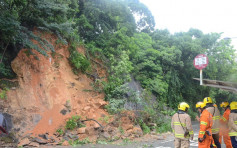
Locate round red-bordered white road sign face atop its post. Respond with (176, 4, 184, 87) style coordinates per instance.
(193, 54, 208, 70)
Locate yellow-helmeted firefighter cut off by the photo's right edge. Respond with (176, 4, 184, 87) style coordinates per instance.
(228, 101, 237, 148)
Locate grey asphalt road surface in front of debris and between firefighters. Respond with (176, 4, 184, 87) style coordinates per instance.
(57, 122, 226, 148)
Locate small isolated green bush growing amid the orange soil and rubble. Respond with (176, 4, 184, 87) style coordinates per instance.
(65, 116, 85, 130)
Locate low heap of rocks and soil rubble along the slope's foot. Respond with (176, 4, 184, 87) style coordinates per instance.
(18, 111, 143, 147)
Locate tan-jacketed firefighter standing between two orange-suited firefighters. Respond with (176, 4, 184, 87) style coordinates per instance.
(203, 97, 221, 148)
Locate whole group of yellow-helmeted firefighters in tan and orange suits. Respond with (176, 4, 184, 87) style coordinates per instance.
(171, 97, 237, 148)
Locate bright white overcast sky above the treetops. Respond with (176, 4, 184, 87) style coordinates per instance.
(140, 0, 237, 49)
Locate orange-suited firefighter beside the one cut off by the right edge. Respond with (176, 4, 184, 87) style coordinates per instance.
(220, 102, 232, 148)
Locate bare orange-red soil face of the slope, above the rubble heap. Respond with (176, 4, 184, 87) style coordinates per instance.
(4, 34, 108, 136)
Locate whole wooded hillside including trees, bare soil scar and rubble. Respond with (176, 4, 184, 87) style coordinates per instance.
(0, 0, 237, 145)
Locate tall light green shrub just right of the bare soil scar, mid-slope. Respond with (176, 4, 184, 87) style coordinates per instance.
(104, 51, 133, 114)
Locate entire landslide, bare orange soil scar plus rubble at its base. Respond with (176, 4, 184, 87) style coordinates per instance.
(0, 34, 143, 146)
